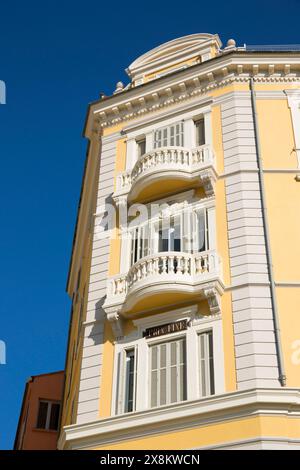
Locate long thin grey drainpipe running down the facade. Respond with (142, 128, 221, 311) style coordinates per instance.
(250, 78, 286, 387)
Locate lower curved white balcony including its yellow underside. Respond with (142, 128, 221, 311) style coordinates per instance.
(103, 250, 223, 316)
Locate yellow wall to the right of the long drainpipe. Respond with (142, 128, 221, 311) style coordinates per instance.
(257, 96, 300, 387)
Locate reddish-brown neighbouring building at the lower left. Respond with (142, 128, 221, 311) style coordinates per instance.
(14, 371, 64, 450)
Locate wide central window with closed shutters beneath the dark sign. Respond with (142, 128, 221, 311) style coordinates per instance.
(150, 338, 186, 407)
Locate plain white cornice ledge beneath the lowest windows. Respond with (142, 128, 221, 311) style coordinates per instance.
(58, 388, 300, 449)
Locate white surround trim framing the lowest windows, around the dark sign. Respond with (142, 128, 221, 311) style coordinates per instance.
(111, 305, 225, 416)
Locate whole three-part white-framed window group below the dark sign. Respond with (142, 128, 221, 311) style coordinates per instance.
(114, 319, 219, 414)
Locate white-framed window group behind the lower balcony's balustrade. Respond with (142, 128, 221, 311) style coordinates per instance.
(129, 205, 210, 265)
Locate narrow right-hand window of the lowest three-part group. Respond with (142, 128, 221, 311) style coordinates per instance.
(199, 331, 215, 397)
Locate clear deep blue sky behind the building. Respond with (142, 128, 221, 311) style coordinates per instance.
(0, 0, 300, 449)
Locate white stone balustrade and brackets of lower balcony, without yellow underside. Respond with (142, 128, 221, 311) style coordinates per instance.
(103, 250, 224, 330)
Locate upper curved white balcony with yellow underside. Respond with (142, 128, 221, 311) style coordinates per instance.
(113, 145, 217, 203)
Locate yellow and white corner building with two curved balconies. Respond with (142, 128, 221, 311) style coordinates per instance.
(59, 34, 300, 450)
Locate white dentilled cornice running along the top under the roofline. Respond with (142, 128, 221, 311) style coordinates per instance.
(90, 53, 300, 131)
